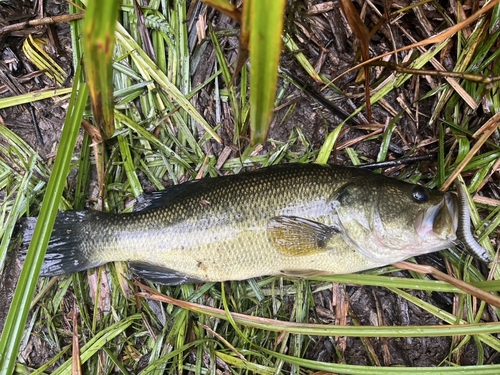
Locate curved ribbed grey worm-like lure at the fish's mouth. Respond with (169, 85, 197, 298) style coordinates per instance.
(455, 179, 492, 263)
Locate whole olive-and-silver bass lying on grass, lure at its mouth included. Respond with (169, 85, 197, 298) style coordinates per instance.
(16, 164, 491, 285)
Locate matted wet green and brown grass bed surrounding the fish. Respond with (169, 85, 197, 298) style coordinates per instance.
(0, 0, 500, 374)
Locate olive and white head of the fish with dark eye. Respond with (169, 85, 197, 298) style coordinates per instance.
(335, 176, 458, 265)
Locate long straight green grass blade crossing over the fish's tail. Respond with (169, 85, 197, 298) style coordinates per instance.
(0, 66, 88, 375)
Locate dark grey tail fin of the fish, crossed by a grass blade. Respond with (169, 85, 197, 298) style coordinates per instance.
(19, 211, 103, 277)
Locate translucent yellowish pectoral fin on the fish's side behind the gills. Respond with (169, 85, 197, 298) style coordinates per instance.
(267, 216, 339, 256)
